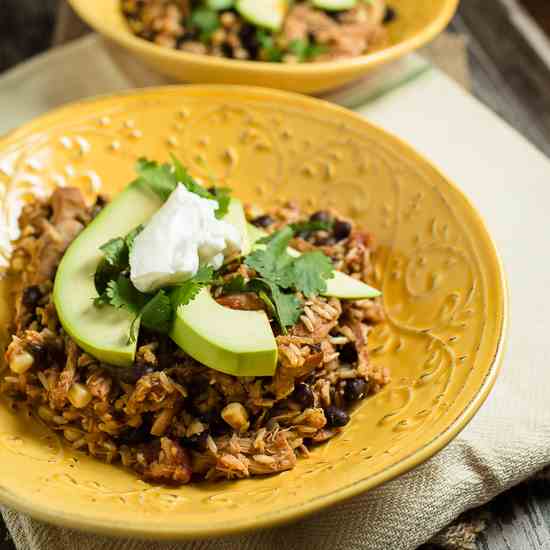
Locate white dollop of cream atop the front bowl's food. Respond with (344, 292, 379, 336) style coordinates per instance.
(130, 184, 243, 292)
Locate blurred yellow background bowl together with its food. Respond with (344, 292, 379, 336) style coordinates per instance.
(70, 0, 458, 93)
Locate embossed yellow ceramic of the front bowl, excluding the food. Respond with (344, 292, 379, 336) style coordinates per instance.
(0, 86, 506, 539)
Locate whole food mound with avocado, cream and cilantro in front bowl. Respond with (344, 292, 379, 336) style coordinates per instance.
(0, 159, 389, 485)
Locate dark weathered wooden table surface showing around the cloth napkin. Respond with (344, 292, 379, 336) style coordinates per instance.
(0, 0, 550, 550)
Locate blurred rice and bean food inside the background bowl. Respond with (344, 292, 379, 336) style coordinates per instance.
(121, 0, 395, 63)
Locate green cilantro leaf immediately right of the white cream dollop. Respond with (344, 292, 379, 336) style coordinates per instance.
(245, 227, 294, 288)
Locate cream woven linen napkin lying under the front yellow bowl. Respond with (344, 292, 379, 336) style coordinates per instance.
(0, 32, 550, 550)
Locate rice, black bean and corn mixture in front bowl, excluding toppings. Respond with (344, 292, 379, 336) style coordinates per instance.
(0, 188, 389, 485)
